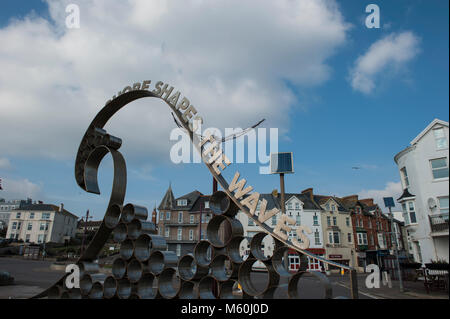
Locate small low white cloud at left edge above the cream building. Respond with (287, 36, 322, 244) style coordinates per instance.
(0, 178, 43, 200)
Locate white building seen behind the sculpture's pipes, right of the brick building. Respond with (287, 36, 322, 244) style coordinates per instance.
(236, 194, 325, 271)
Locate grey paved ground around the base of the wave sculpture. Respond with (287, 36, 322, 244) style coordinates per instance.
(0, 257, 449, 299)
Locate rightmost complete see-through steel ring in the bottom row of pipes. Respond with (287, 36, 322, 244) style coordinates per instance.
(239, 258, 280, 296)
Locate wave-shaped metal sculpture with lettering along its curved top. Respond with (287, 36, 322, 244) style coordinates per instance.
(34, 81, 357, 299)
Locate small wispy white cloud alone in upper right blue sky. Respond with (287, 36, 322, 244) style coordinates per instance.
(350, 31, 420, 94)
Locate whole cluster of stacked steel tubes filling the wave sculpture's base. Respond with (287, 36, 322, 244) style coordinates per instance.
(48, 191, 332, 299)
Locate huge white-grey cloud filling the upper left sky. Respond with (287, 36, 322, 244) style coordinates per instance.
(0, 0, 348, 165)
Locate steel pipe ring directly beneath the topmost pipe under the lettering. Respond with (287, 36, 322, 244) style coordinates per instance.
(206, 215, 244, 248)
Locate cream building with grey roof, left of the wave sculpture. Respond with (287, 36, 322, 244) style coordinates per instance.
(6, 204, 78, 244)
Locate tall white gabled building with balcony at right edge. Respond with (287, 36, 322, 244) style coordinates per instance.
(394, 119, 449, 263)
